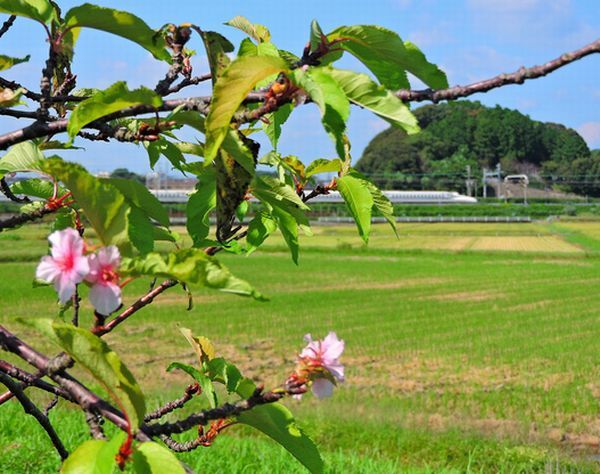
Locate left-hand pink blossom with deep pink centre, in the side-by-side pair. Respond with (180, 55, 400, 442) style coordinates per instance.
(35, 228, 90, 304)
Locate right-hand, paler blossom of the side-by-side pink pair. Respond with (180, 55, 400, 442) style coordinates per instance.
(85, 245, 121, 316)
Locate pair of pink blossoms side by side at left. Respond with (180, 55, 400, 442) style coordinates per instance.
(35, 228, 121, 316)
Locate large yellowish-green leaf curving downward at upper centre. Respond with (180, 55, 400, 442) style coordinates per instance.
(205, 56, 287, 162)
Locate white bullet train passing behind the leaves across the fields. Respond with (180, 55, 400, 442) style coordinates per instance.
(150, 189, 477, 204)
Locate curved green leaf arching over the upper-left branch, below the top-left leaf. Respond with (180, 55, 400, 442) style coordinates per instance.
(67, 81, 162, 141)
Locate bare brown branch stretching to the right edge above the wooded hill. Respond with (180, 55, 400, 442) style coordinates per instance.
(396, 39, 600, 103)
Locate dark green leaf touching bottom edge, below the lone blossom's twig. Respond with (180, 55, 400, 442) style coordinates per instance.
(238, 403, 323, 473)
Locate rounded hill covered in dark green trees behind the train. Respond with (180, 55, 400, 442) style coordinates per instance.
(356, 101, 600, 196)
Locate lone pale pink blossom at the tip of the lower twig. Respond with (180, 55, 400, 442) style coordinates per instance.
(293, 332, 344, 398)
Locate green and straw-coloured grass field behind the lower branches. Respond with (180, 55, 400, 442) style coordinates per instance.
(0, 222, 600, 473)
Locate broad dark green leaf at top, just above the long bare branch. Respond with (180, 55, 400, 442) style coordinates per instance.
(327, 25, 448, 90)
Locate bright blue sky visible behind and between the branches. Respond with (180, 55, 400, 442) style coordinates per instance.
(0, 0, 600, 172)
